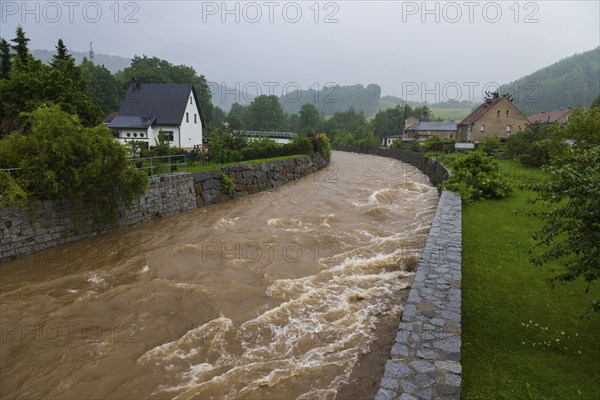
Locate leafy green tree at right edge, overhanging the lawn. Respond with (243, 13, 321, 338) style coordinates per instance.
(530, 145, 600, 312)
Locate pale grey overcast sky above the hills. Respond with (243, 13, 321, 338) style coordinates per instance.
(0, 0, 600, 102)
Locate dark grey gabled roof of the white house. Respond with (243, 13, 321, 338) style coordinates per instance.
(108, 82, 204, 128)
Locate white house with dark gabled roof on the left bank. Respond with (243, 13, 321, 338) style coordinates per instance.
(108, 82, 204, 149)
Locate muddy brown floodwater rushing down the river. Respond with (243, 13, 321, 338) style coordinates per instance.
(0, 152, 438, 399)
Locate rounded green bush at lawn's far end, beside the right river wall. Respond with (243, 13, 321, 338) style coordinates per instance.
(443, 151, 511, 202)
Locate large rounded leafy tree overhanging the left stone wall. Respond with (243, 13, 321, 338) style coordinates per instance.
(0, 105, 148, 222)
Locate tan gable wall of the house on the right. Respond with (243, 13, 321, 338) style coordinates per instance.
(466, 99, 529, 142)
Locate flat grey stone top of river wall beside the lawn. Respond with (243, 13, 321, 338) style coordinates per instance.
(375, 190, 462, 400)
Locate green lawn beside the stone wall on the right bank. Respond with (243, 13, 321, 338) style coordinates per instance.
(462, 160, 600, 400)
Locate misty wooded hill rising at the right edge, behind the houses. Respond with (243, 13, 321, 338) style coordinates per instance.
(499, 47, 600, 114)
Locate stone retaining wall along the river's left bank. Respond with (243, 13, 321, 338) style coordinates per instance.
(0, 156, 329, 262)
